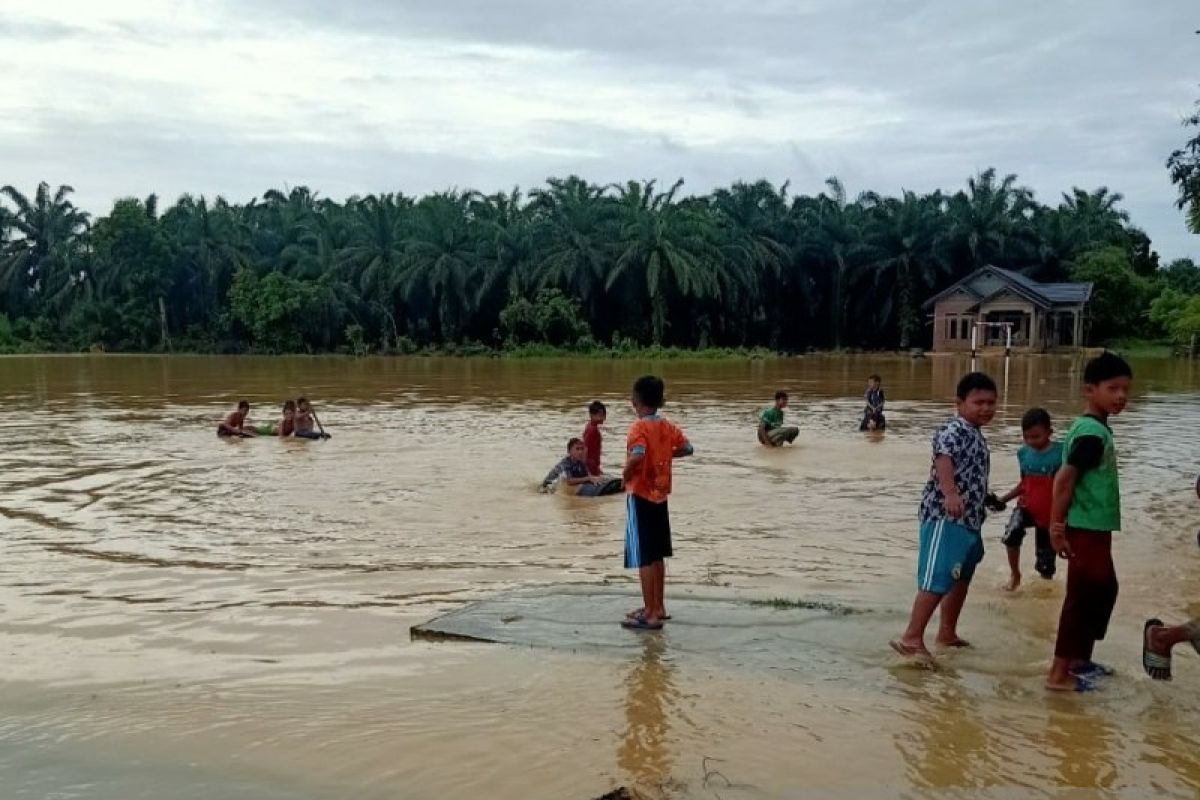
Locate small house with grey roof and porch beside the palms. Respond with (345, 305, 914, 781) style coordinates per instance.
(923, 266, 1092, 353)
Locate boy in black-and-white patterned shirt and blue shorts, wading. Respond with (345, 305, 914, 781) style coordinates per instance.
(890, 372, 996, 662)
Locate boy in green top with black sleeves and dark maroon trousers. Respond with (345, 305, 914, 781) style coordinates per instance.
(1046, 353, 1133, 692)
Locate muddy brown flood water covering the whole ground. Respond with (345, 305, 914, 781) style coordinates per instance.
(0, 356, 1200, 800)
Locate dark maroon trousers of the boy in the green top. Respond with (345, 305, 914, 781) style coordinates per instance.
(1054, 528, 1118, 661)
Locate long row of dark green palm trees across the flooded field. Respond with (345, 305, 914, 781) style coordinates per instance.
(0, 169, 1154, 350)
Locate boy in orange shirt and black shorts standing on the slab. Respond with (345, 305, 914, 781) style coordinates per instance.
(620, 375, 692, 631)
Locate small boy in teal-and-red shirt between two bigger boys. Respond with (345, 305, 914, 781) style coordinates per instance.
(1000, 408, 1062, 591)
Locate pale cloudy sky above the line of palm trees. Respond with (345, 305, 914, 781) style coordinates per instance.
(0, 0, 1200, 260)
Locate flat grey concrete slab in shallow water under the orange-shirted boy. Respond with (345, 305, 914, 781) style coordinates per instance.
(412, 589, 854, 661)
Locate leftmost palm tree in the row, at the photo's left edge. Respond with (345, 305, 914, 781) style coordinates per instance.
(0, 181, 88, 311)
